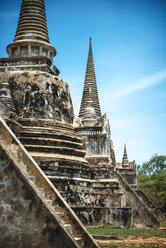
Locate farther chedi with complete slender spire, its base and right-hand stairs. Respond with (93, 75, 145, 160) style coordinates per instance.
(74, 39, 161, 227)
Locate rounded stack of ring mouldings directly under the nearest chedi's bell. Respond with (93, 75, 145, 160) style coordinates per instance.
(20, 119, 87, 177)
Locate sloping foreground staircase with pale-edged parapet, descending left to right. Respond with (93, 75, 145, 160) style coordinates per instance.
(0, 117, 99, 248)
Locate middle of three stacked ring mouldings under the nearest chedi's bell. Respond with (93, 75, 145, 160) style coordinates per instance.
(20, 129, 82, 144)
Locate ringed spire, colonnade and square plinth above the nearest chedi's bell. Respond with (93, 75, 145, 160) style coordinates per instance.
(7, 0, 59, 75)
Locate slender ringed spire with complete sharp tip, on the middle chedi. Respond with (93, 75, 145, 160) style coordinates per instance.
(79, 38, 101, 118)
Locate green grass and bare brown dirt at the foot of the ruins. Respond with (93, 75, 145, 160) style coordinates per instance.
(87, 221, 166, 248)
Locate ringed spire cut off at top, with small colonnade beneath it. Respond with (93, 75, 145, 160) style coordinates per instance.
(7, 0, 56, 61)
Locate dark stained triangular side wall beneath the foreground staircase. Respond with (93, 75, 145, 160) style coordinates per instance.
(0, 149, 73, 248)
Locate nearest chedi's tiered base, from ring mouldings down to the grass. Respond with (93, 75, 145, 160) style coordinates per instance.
(17, 119, 130, 227)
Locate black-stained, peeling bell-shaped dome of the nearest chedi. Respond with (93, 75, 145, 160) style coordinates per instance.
(0, 71, 74, 124)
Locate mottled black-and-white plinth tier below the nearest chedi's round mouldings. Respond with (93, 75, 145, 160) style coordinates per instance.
(49, 176, 121, 208)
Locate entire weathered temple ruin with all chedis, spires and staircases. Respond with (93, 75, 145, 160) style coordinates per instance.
(0, 0, 162, 248)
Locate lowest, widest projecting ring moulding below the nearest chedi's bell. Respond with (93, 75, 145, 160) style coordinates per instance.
(24, 145, 86, 157)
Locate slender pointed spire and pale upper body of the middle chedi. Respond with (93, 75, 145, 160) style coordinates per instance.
(74, 38, 115, 179)
